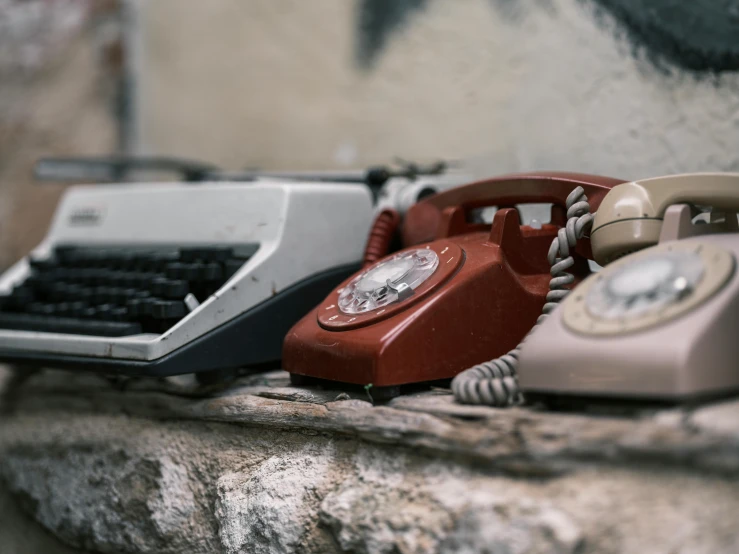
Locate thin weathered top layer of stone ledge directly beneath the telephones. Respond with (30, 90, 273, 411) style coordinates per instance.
(5, 371, 739, 475)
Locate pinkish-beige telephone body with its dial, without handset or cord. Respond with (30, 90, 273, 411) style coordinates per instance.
(518, 204, 739, 402)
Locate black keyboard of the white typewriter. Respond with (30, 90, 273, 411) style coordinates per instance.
(0, 244, 258, 337)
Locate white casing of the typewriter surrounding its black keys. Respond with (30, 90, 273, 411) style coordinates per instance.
(0, 180, 373, 365)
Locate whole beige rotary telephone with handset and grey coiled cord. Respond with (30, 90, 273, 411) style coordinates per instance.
(453, 173, 739, 405)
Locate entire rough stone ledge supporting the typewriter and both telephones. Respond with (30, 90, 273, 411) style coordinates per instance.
(0, 364, 739, 554)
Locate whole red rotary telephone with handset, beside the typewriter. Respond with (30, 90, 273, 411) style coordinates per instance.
(283, 172, 624, 398)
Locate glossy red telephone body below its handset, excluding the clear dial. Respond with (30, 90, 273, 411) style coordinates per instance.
(283, 208, 588, 390)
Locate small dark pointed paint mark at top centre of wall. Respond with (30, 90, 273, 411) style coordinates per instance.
(356, 0, 428, 69)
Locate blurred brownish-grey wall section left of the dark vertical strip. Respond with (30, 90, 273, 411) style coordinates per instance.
(0, 0, 116, 270)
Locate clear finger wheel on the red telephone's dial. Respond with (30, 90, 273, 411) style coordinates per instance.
(338, 248, 439, 314)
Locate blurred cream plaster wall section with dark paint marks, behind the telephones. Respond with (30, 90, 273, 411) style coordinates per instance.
(136, 0, 739, 178)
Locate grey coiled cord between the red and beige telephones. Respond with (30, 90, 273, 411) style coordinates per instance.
(452, 187, 594, 407)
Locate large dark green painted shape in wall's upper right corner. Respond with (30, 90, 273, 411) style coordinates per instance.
(581, 0, 739, 73)
